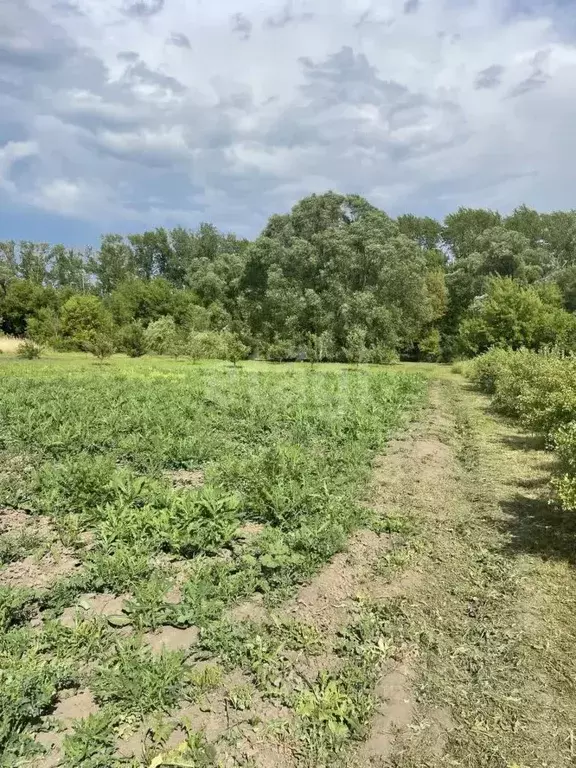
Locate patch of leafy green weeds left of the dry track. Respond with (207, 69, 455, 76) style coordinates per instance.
(0, 355, 425, 768)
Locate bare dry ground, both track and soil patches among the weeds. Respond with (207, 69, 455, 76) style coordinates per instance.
(0, 358, 576, 768)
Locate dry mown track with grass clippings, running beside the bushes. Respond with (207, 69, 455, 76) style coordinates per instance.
(354, 378, 576, 768)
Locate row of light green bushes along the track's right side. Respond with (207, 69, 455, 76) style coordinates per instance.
(468, 349, 576, 511)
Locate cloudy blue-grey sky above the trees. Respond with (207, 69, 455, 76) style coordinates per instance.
(0, 0, 576, 245)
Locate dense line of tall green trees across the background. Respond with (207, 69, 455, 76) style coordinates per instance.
(0, 192, 576, 362)
